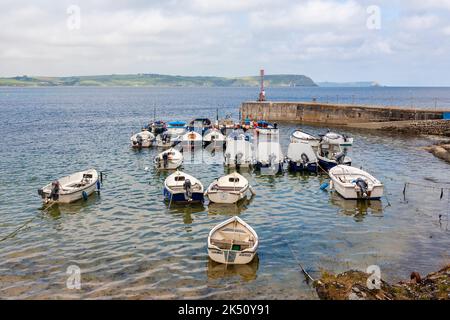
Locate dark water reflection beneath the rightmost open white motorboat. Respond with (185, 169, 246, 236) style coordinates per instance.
(330, 192, 383, 221)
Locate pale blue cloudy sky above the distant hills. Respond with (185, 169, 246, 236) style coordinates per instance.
(0, 0, 450, 86)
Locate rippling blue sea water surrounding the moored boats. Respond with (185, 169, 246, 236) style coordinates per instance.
(0, 88, 450, 299)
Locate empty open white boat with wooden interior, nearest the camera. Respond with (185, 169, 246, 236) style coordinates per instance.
(208, 216, 259, 264)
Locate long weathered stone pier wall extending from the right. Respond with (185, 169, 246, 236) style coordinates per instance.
(240, 101, 450, 126)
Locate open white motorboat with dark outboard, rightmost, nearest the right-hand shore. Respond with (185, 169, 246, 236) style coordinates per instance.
(329, 165, 384, 200)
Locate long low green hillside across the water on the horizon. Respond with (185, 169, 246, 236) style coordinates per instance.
(0, 74, 317, 87)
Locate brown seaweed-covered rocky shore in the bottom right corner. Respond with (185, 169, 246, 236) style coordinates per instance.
(314, 265, 450, 300)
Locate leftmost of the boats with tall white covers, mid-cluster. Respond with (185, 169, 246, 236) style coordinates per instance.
(224, 135, 255, 168)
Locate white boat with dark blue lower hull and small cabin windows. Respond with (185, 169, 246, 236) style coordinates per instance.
(164, 170, 204, 203)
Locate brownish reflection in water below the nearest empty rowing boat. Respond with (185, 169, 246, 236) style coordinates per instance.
(207, 254, 259, 281)
